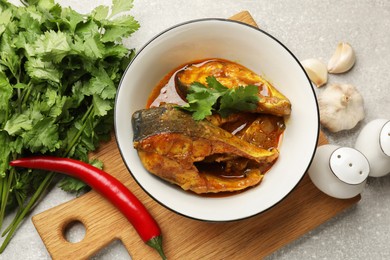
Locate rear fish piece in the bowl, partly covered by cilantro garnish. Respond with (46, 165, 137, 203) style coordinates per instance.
(175, 59, 291, 116)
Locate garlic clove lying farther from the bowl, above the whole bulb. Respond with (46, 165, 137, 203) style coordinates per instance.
(328, 42, 356, 74)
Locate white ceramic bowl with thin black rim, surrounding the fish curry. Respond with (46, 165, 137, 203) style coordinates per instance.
(115, 19, 319, 221)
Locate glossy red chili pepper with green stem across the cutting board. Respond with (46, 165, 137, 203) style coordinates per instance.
(10, 156, 167, 259)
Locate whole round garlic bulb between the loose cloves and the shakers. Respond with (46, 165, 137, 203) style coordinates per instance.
(318, 84, 365, 132)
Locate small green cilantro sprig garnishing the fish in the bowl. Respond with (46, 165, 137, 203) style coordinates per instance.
(180, 76, 259, 120)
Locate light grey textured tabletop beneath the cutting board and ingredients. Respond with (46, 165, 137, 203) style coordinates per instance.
(0, 0, 390, 259)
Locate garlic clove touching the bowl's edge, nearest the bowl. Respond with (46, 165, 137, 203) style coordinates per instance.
(301, 59, 328, 87)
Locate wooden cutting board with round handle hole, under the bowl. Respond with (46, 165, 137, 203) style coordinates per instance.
(32, 11, 360, 260)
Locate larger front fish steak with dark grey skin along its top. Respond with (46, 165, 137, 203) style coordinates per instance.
(132, 106, 279, 193)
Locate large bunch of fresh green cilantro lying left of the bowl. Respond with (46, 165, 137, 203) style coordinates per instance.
(0, 0, 139, 253)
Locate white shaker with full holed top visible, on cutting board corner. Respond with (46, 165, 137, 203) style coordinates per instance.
(308, 144, 370, 199)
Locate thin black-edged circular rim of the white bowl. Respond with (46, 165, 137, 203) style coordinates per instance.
(114, 18, 320, 223)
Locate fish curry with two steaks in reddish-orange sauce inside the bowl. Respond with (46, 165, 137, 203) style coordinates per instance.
(132, 59, 291, 194)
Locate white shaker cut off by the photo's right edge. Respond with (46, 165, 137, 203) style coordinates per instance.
(355, 119, 390, 177)
